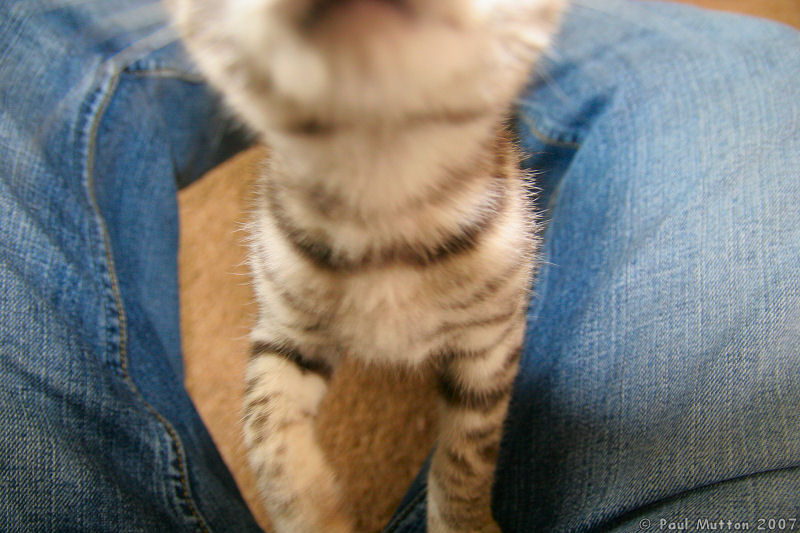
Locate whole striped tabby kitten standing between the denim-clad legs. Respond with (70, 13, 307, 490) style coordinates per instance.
(171, 0, 563, 533)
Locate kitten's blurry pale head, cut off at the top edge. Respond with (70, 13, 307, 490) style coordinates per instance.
(168, 0, 563, 132)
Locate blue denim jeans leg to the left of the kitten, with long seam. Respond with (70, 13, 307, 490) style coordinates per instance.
(0, 0, 258, 531)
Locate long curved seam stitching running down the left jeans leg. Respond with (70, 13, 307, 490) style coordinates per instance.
(84, 63, 210, 533)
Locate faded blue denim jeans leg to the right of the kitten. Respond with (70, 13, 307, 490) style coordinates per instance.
(387, 0, 800, 533)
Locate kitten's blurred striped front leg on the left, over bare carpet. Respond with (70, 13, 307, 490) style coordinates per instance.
(244, 342, 353, 533)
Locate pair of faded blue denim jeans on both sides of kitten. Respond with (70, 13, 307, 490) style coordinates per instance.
(0, 0, 800, 532)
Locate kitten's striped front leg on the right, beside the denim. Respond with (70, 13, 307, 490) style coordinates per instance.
(428, 319, 525, 533)
